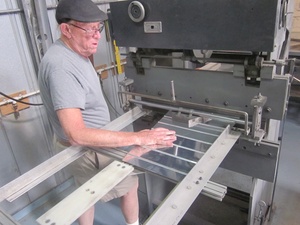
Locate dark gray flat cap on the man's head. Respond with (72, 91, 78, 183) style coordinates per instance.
(55, 0, 107, 24)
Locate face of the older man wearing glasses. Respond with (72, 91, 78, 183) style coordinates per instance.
(68, 21, 103, 57)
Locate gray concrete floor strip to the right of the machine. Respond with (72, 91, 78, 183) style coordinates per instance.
(266, 100, 300, 225)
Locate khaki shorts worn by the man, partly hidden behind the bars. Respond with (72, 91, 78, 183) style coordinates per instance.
(54, 138, 138, 202)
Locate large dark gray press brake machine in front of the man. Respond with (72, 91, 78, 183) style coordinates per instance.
(109, 0, 294, 224)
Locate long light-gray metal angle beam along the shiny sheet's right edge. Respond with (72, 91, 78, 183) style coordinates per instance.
(144, 126, 241, 225)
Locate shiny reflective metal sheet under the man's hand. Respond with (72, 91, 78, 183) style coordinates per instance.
(123, 116, 228, 181)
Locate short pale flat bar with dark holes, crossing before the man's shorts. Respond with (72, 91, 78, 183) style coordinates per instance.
(37, 161, 133, 225)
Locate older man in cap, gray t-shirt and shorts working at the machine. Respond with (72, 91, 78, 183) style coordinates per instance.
(38, 0, 176, 225)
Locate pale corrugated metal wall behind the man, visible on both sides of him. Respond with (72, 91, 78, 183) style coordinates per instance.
(0, 0, 121, 214)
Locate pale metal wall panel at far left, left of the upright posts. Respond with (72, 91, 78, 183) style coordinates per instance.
(0, 0, 57, 213)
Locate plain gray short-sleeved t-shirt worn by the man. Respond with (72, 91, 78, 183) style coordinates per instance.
(38, 39, 110, 141)
